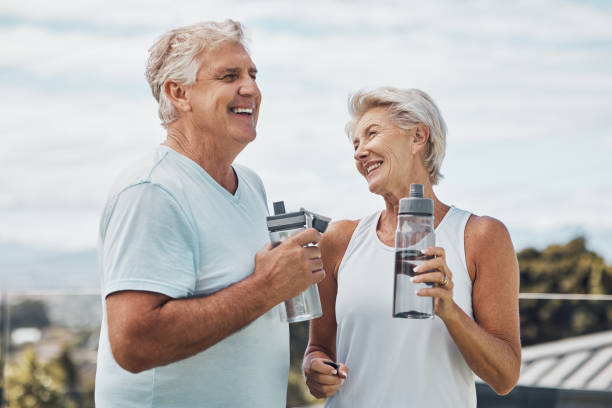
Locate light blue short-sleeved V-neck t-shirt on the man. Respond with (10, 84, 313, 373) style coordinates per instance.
(95, 146, 289, 408)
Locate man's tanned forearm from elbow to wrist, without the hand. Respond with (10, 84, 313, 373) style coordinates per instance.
(111, 275, 278, 372)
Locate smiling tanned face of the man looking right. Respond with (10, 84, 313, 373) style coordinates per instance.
(188, 43, 261, 145)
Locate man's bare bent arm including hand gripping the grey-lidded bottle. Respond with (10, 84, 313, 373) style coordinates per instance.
(106, 228, 325, 373)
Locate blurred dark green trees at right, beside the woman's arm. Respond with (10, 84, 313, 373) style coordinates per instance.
(517, 237, 612, 346)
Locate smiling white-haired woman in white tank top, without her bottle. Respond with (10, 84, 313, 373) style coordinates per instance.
(304, 88, 521, 408)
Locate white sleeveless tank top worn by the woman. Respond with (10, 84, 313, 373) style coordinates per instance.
(325, 207, 476, 408)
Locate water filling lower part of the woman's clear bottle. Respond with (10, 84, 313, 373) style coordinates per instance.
(393, 249, 434, 319)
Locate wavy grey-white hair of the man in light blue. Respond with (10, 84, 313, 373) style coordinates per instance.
(145, 20, 248, 128)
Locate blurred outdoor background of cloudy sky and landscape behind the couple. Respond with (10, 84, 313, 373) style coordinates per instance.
(0, 0, 612, 407)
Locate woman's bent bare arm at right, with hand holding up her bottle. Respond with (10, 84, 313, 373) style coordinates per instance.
(417, 216, 521, 395)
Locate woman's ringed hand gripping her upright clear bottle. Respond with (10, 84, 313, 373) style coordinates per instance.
(411, 247, 455, 320)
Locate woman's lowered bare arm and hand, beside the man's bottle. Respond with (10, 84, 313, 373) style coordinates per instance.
(303, 221, 358, 398)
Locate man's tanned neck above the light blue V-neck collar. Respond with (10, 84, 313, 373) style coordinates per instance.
(162, 124, 242, 194)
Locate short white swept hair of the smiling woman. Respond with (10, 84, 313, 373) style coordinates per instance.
(346, 87, 446, 185)
